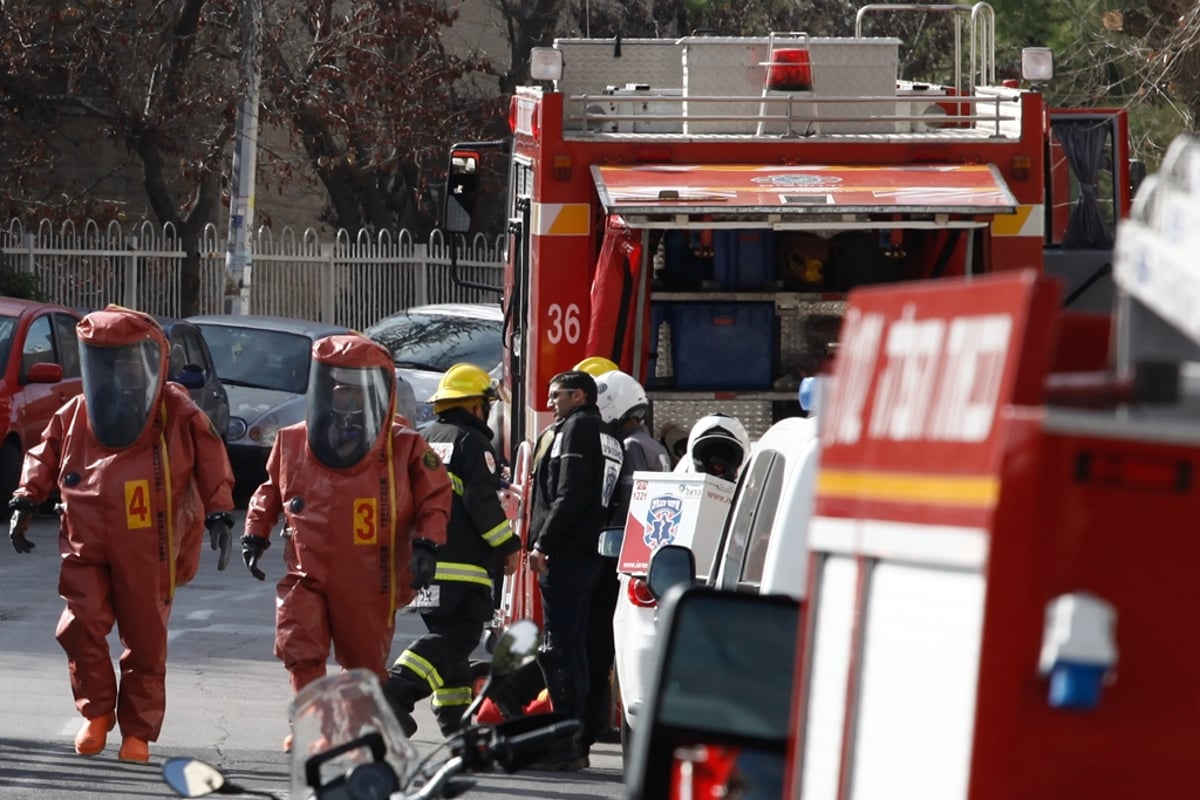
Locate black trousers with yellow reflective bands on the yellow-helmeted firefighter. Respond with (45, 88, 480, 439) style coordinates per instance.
(386, 614, 484, 735)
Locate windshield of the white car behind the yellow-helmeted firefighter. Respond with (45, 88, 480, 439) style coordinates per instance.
(366, 313, 502, 372)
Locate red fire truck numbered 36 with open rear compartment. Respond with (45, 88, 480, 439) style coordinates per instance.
(444, 2, 1130, 671)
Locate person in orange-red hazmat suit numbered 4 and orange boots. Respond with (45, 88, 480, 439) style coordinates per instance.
(10, 306, 233, 762)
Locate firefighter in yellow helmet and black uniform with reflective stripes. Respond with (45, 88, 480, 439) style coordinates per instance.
(386, 363, 521, 735)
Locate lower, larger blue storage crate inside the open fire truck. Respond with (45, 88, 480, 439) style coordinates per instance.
(670, 302, 775, 389)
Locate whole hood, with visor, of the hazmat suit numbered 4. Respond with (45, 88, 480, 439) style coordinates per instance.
(76, 306, 168, 450)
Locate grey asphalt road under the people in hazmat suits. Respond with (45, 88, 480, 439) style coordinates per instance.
(0, 515, 624, 800)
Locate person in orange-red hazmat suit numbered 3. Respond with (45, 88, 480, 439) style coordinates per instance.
(241, 333, 454, 750)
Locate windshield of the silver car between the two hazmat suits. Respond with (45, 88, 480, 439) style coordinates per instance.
(200, 323, 312, 395)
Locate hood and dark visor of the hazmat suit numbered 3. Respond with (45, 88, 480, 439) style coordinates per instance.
(306, 333, 396, 469)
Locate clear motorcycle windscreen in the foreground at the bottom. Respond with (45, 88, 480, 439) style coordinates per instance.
(288, 669, 416, 800)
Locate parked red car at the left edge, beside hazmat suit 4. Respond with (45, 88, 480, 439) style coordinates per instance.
(0, 297, 83, 506)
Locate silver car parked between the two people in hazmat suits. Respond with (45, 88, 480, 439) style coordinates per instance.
(188, 314, 416, 493)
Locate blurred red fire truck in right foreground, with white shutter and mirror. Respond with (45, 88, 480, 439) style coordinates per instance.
(626, 134, 1200, 800)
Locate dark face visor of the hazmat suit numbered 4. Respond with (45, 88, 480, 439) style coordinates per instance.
(79, 339, 162, 450)
